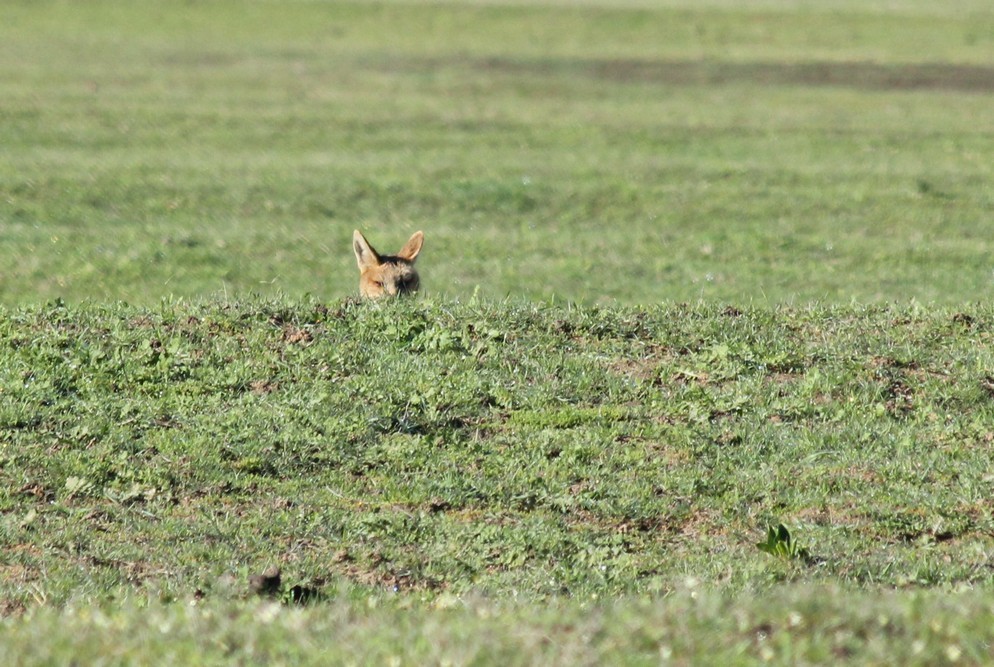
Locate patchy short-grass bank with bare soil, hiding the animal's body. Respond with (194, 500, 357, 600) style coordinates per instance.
(0, 299, 994, 662)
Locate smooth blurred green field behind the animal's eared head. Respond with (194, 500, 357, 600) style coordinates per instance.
(0, 2, 994, 305)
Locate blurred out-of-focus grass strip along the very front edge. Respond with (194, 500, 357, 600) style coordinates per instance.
(0, 588, 994, 666)
